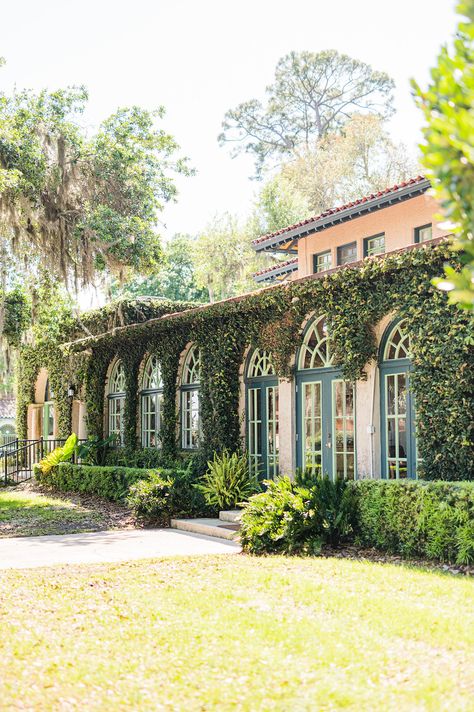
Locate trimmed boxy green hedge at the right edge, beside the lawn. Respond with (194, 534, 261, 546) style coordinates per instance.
(352, 481, 474, 564)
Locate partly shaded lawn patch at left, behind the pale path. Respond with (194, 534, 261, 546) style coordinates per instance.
(0, 483, 130, 536)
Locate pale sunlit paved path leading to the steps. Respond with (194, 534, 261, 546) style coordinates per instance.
(0, 529, 241, 569)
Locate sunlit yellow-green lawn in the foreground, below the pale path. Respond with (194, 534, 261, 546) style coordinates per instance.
(0, 555, 474, 712)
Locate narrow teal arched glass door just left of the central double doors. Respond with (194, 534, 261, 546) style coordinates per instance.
(246, 349, 279, 478)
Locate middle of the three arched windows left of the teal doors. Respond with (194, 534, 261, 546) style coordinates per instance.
(141, 355, 163, 448)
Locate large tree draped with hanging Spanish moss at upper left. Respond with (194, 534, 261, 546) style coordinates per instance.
(0, 78, 190, 286)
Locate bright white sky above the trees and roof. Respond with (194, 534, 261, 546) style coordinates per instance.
(0, 0, 455, 235)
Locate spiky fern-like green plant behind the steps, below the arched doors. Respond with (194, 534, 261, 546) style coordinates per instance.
(195, 450, 260, 509)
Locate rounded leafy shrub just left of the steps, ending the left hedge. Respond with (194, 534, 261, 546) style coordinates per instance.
(128, 467, 216, 526)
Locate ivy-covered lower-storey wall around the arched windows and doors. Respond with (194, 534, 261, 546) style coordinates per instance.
(18, 241, 474, 480)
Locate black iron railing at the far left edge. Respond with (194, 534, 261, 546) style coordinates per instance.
(0, 438, 85, 484)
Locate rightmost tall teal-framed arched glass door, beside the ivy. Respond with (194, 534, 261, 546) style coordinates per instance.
(380, 320, 416, 479)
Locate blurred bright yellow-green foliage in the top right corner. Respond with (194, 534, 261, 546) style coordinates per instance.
(413, 0, 474, 310)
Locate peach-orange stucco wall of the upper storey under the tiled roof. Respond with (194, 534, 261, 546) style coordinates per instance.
(292, 193, 447, 279)
